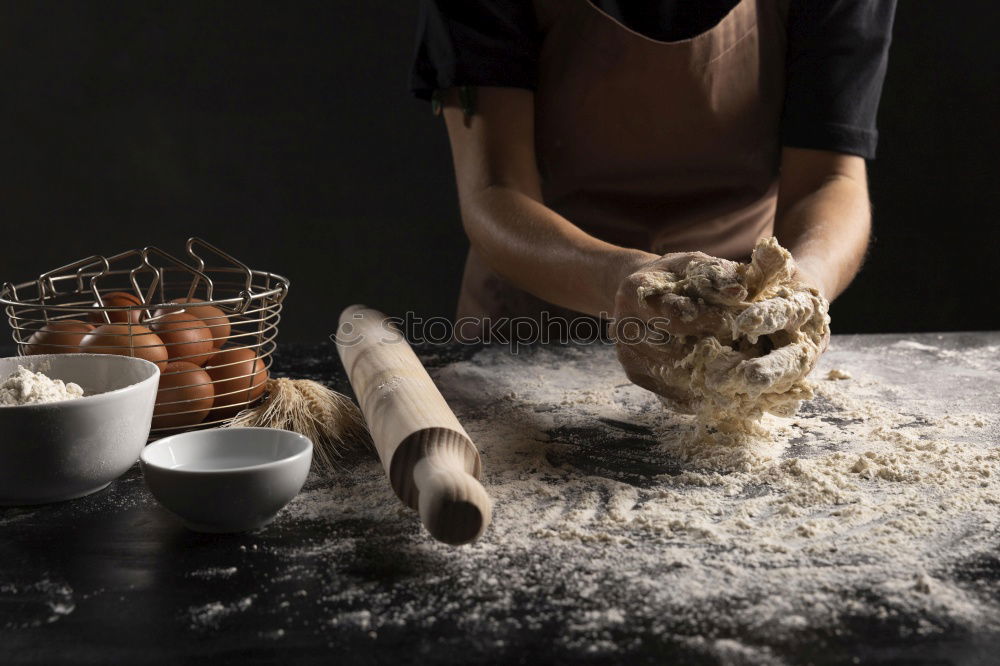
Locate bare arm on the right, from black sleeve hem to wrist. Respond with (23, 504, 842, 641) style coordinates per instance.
(774, 148, 871, 301)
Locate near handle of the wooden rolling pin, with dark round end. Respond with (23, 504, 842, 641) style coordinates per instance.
(413, 452, 493, 546)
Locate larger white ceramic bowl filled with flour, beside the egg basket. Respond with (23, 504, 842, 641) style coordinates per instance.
(0, 354, 160, 506)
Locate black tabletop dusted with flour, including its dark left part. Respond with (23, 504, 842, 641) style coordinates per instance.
(0, 334, 1000, 664)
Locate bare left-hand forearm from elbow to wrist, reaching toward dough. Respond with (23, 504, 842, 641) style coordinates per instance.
(462, 184, 656, 315)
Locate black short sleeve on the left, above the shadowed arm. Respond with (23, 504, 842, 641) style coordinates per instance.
(410, 0, 539, 99)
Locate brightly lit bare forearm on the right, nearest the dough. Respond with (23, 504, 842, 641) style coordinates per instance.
(774, 154, 871, 301)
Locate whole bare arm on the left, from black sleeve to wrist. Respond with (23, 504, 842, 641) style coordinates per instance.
(444, 87, 656, 315)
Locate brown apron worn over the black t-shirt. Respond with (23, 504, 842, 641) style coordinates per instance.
(458, 0, 785, 318)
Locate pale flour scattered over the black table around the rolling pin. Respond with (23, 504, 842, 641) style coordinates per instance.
(270, 340, 1000, 664)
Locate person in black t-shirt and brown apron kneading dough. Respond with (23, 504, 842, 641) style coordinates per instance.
(411, 0, 895, 384)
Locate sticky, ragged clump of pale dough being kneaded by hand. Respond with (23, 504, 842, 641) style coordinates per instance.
(637, 237, 830, 439)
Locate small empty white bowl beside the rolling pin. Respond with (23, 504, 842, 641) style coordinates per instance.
(140, 428, 313, 532)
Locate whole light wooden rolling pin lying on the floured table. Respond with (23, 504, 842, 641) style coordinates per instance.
(337, 305, 493, 545)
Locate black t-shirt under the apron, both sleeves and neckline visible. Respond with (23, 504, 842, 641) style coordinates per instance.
(410, 0, 896, 159)
